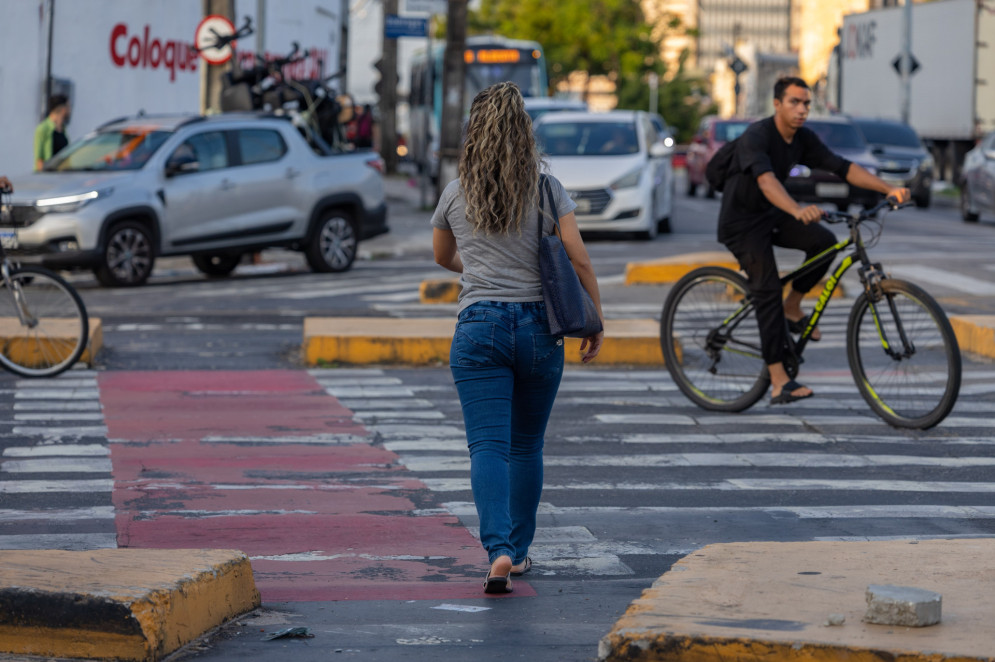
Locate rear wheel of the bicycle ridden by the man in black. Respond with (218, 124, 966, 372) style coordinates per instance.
(660, 267, 770, 412)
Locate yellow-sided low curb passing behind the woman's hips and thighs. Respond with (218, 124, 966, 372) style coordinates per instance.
(303, 317, 663, 365)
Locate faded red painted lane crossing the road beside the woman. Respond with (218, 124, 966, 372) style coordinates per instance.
(99, 371, 535, 601)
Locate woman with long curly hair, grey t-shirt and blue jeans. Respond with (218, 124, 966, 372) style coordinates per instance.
(432, 83, 604, 593)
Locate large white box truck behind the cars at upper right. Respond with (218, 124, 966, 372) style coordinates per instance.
(839, 0, 995, 182)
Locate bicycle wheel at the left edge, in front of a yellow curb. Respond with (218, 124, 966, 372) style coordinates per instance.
(0, 266, 90, 377)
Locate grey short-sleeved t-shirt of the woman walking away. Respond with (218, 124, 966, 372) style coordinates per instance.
(432, 175, 577, 311)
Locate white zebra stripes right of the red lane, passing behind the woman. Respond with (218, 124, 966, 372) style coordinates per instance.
(332, 366, 995, 576)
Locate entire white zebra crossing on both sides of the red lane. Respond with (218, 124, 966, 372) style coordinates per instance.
(0, 364, 995, 577)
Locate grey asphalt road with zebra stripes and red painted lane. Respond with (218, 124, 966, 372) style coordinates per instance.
(0, 182, 995, 661)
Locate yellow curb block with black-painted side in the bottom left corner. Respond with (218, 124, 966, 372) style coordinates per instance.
(0, 549, 260, 661)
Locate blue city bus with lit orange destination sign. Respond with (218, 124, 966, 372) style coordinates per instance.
(408, 35, 549, 180)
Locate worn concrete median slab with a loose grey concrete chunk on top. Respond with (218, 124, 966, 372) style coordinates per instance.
(598, 539, 995, 662)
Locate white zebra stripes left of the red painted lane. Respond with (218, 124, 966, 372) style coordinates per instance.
(0, 370, 117, 549)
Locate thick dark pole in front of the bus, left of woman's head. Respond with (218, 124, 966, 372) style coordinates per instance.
(437, 0, 467, 197)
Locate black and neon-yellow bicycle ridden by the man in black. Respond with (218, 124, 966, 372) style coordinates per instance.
(660, 200, 961, 430)
